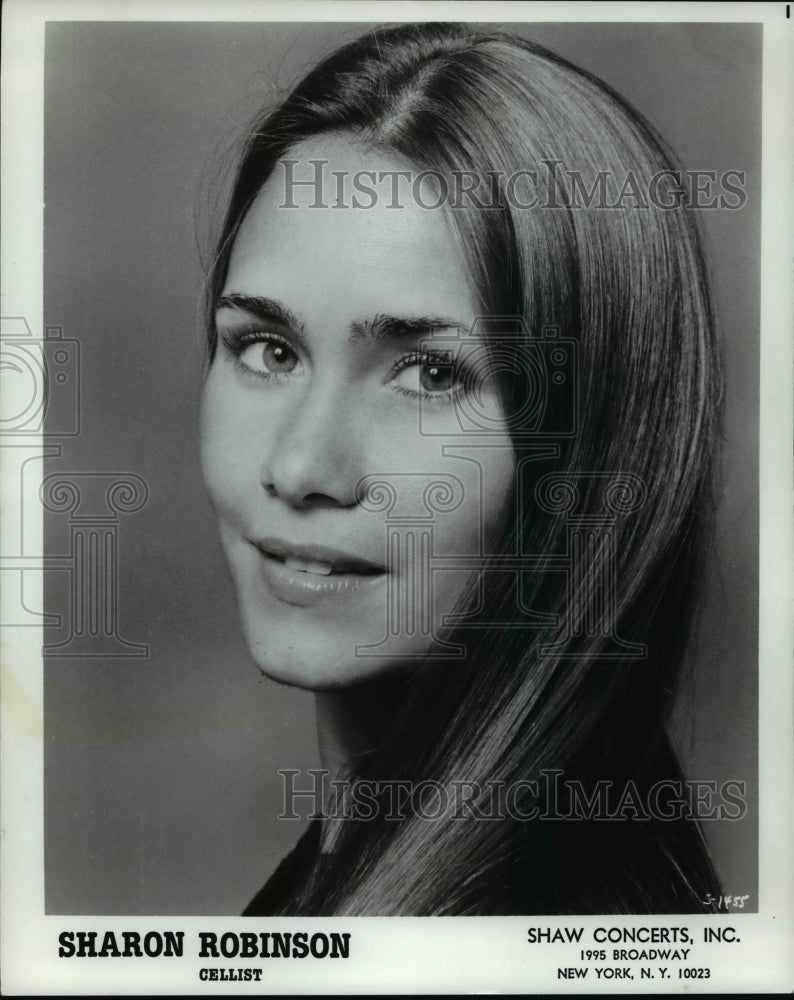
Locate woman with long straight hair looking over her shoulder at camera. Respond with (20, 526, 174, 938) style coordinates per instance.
(202, 24, 719, 915)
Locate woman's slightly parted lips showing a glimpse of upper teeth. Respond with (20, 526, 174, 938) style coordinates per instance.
(251, 538, 386, 606)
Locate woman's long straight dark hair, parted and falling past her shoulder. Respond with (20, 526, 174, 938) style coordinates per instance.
(208, 23, 720, 915)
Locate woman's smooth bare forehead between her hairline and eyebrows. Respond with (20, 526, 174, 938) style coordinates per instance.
(225, 136, 477, 322)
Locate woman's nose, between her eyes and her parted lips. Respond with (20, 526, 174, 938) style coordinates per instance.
(262, 385, 367, 509)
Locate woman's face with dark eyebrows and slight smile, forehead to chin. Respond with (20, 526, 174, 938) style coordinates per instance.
(201, 137, 514, 690)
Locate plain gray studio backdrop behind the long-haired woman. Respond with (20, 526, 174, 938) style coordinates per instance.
(44, 23, 761, 914)
